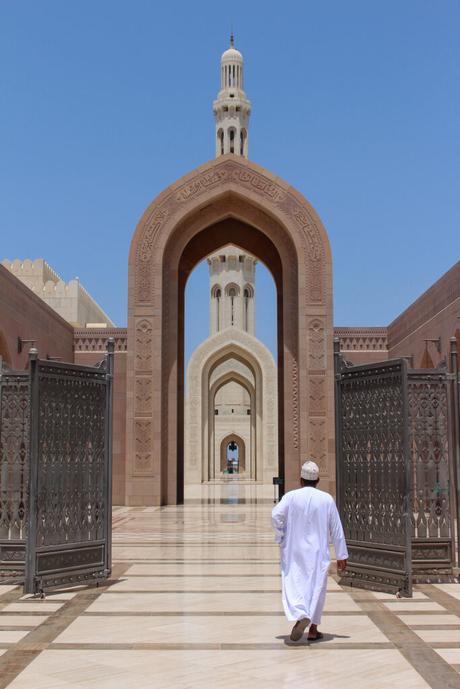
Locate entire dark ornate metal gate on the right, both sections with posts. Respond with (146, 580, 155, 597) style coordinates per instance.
(335, 344, 454, 596)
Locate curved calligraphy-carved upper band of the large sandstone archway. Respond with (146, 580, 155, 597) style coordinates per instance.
(130, 155, 331, 303)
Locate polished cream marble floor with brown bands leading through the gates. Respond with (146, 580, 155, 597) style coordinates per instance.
(0, 482, 460, 689)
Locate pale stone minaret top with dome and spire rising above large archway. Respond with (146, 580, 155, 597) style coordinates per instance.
(213, 33, 251, 158)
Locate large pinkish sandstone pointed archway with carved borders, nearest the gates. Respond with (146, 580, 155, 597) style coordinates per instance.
(126, 155, 335, 505)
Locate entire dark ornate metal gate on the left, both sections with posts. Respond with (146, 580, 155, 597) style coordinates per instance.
(0, 341, 114, 593)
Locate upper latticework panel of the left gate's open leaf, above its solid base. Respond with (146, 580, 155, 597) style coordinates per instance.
(37, 362, 106, 546)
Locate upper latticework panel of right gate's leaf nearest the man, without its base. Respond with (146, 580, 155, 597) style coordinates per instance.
(342, 365, 405, 545)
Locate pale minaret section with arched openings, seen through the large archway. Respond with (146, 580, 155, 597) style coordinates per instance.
(208, 246, 257, 335)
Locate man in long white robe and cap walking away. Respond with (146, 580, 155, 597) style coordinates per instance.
(272, 461, 348, 641)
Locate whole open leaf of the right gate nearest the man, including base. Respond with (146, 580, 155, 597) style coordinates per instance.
(337, 361, 411, 595)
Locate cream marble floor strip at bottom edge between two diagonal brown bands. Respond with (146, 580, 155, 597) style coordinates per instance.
(2, 649, 428, 689)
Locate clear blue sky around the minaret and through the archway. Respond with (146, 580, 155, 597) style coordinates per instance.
(0, 0, 460, 362)
